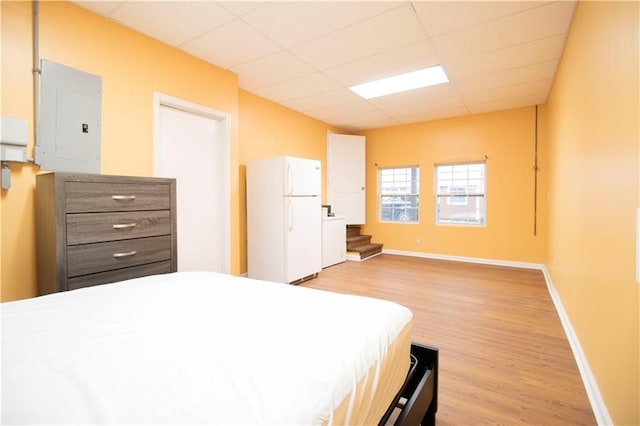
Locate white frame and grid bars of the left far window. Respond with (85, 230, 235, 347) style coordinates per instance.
(377, 164, 420, 224)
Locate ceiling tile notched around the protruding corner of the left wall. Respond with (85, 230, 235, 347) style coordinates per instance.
(231, 50, 315, 90)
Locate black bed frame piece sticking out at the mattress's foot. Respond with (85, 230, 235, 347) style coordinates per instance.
(378, 343, 438, 426)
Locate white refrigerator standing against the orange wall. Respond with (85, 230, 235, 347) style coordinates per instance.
(247, 157, 322, 283)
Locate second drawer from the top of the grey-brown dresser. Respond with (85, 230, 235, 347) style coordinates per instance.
(67, 210, 171, 245)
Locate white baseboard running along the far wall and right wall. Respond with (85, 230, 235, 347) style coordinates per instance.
(382, 249, 613, 425)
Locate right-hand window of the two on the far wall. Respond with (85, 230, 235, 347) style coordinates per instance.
(435, 162, 486, 226)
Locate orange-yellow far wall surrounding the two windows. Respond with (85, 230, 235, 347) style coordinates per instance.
(363, 107, 546, 263)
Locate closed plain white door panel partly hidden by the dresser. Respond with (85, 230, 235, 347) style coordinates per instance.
(155, 94, 230, 272)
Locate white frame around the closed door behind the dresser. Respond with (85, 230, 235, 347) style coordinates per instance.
(153, 92, 231, 274)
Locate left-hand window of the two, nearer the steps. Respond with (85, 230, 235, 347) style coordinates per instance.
(378, 166, 420, 223)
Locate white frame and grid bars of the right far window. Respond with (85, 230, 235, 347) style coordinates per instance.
(433, 160, 487, 228)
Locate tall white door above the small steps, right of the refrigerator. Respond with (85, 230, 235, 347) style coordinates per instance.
(327, 133, 365, 225)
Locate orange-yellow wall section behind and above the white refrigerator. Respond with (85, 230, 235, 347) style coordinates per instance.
(238, 90, 338, 271)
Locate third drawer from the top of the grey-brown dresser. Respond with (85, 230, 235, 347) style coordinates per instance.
(67, 235, 172, 277)
